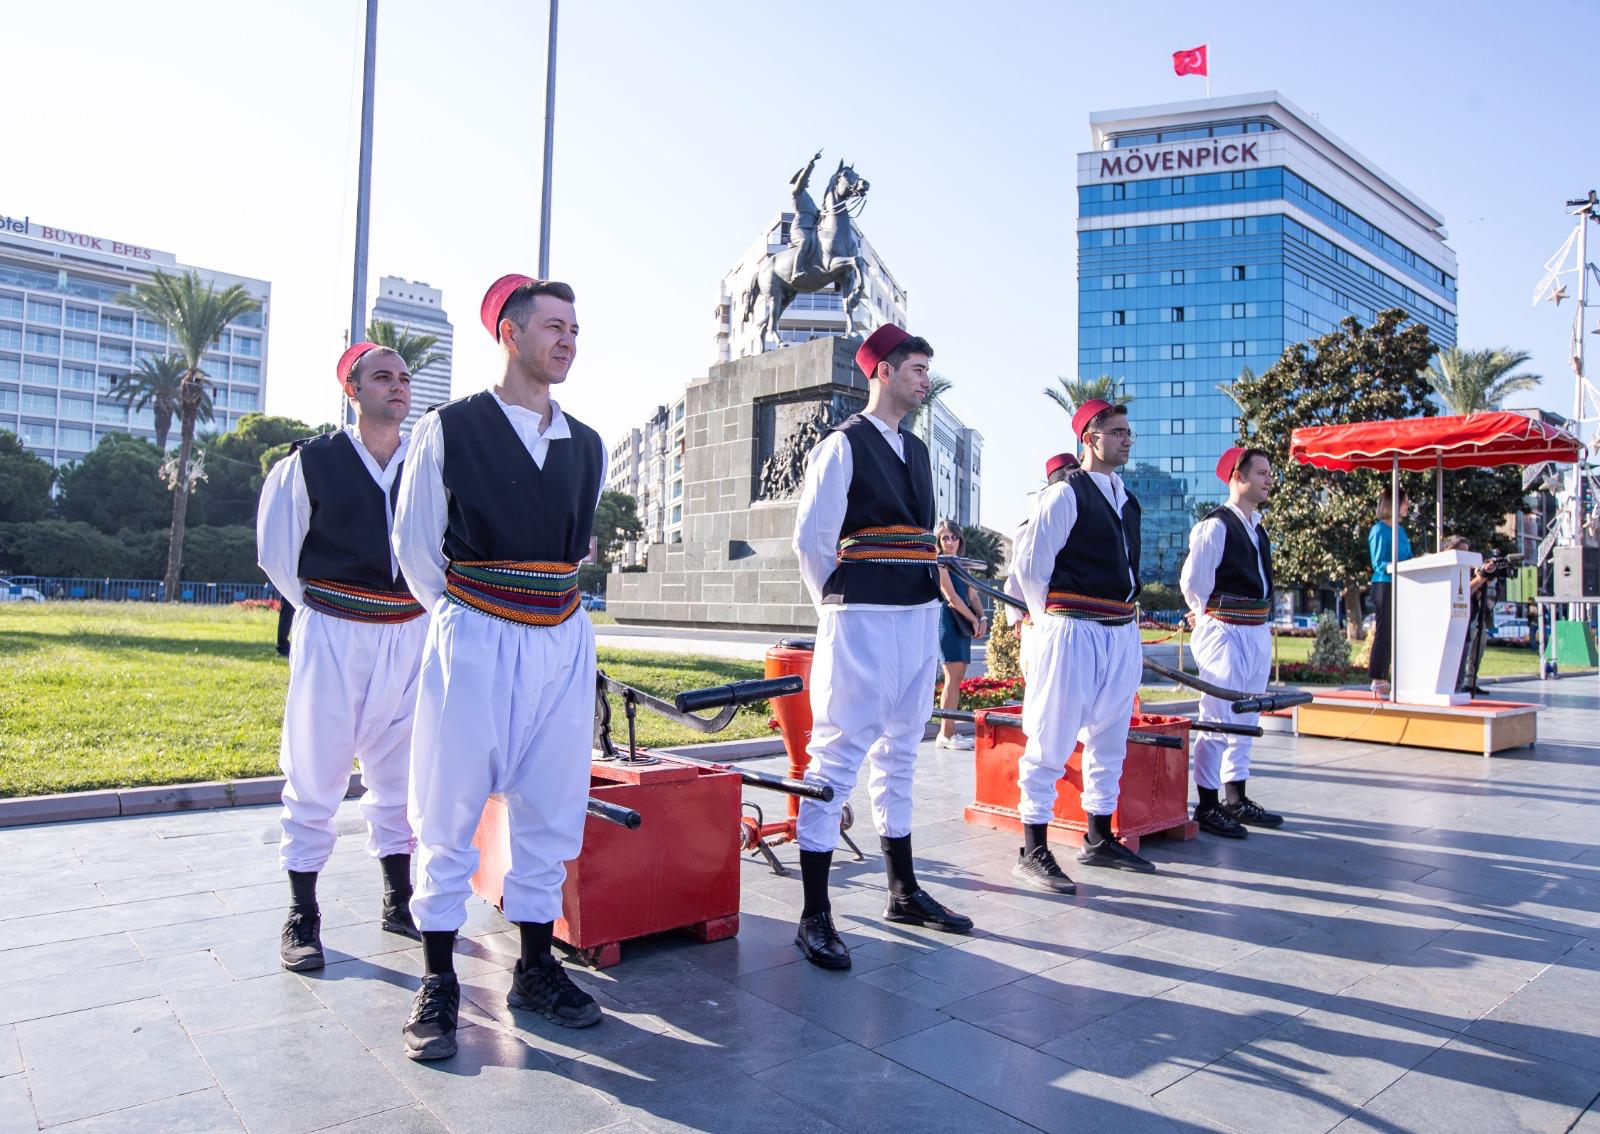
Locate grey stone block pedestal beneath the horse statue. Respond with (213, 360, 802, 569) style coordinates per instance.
(606, 337, 867, 630)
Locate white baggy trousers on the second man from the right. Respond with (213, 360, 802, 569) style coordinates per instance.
(1018, 614, 1144, 824)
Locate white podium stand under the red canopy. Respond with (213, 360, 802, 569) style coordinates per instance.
(1394, 552, 1483, 705)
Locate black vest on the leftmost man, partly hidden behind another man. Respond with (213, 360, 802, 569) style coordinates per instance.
(294, 429, 405, 590)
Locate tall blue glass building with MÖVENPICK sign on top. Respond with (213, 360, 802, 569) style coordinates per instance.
(1078, 91, 1456, 582)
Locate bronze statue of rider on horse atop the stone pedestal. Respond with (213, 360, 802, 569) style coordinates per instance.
(741, 150, 874, 350)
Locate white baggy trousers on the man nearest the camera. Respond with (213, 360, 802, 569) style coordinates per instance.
(411, 598, 595, 931)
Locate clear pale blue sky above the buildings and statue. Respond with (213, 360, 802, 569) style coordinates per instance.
(0, 0, 1600, 531)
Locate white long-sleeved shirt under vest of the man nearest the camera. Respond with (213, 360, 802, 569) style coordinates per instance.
(394, 390, 611, 609)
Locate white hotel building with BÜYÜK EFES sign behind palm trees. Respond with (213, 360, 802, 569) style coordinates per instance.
(0, 214, 272, 465)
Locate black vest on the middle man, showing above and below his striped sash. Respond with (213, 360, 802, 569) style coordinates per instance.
(822, 414, 939, 606)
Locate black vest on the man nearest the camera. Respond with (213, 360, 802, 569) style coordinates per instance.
(438, 390, 605, 563)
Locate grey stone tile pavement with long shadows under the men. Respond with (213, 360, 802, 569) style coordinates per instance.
(0, 681, 1600, 1134)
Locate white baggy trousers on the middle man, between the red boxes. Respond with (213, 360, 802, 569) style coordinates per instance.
(797, 605, 939, 851)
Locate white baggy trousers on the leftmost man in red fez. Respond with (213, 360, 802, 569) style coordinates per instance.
(278, 606, 427, 870)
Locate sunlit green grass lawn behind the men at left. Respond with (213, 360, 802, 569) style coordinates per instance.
(0, 603, 768, 797)
